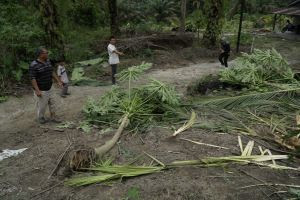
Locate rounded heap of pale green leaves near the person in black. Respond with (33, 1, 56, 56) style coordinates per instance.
(220, 49, 297, 88)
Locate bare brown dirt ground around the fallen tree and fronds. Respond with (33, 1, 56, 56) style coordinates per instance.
(0, 50, 300, 200)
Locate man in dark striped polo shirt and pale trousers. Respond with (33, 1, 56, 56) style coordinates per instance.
(29, 48, 62, 124)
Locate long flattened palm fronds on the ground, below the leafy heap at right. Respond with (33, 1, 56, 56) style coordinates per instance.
(197, 88, 300, 149)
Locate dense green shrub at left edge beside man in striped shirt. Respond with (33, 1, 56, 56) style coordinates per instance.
(0, 2, 44, 90)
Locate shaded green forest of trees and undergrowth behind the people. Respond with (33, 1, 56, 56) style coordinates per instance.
(0, 0, 292, 96)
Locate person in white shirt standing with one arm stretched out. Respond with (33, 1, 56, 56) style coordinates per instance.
(107, 36, 124, 84)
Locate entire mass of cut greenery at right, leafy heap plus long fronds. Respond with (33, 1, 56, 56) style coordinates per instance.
(193, 49, 300, 149)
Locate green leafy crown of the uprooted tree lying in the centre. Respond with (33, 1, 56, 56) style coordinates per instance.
(83, 63, 180, 130)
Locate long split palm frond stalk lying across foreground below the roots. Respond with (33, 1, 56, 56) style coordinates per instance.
(66, 155, 292, 187)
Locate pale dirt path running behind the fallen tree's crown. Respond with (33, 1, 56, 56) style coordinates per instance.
(0, 63, 219, 132)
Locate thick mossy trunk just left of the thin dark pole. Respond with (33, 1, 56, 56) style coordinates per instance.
(202, 0, 224, 48)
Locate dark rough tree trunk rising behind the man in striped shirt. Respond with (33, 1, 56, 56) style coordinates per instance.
(39, 0, 65, 59)
